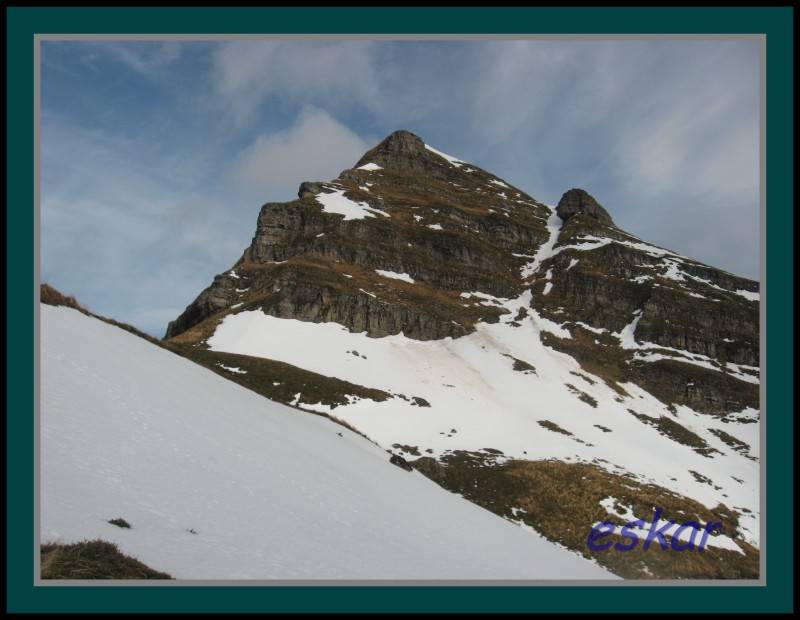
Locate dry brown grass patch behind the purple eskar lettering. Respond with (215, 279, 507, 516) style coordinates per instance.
(413, 451, 759, 579)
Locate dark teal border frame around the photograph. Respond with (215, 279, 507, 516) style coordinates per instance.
(6, 7, 794, 613)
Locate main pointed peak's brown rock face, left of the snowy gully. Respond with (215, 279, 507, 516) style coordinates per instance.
(166, 131, 549, 340)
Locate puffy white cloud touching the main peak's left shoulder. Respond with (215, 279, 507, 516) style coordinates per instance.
(231, 107, 371, 201)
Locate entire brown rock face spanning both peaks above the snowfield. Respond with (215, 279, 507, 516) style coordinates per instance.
(165, 131, 759, 415)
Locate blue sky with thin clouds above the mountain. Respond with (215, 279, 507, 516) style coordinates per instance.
(41, 40, 759, 336)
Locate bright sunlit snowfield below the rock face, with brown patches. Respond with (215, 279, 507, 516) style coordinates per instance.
(208, 292, 759, 545)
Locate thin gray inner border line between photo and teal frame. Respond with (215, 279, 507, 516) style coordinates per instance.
(32, 33, 767, 587)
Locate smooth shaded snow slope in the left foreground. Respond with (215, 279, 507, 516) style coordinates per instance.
(40, 306, 613, 579)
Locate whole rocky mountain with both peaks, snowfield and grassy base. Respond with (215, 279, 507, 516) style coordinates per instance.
(164, 131, 760, 578)
